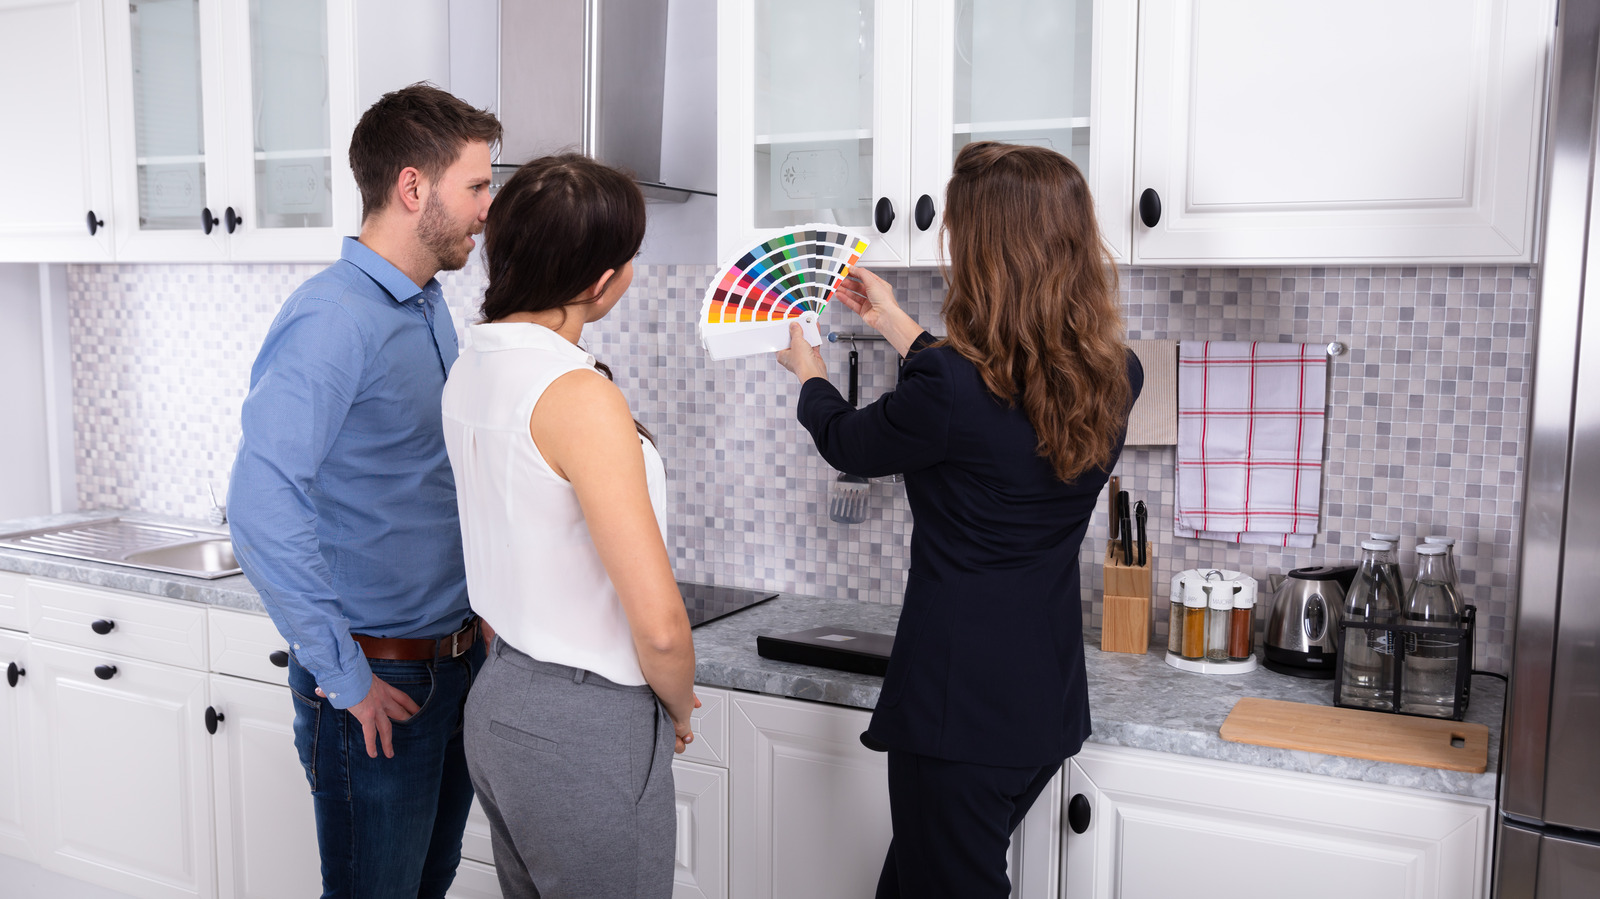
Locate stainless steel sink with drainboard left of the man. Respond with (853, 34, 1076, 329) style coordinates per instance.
(0, 518, 240, 579)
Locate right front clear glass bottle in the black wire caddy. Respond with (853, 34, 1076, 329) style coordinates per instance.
(1400, 544, 1461, 718)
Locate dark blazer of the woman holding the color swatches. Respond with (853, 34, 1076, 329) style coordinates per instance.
(797, 331, 1144, 768)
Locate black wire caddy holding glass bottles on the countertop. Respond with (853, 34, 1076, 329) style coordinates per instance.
(1333, 605, 1477, 721)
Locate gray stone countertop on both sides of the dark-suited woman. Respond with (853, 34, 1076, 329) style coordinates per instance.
(694, 593, 1506, 800)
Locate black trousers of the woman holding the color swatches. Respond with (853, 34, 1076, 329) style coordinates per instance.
(877, 749, 1061, 899)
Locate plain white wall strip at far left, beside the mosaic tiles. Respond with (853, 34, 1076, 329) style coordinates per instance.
(0, 264, 56, 521)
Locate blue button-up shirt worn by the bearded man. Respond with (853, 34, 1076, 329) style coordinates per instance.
(227, 238, 470, 709)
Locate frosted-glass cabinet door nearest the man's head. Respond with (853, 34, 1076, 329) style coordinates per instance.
(226, 0, 358, 261)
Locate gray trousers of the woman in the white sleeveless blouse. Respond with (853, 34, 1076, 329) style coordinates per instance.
(466, 638, 677, 899)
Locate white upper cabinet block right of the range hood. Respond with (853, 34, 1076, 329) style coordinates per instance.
(718, 0, 1554, 267)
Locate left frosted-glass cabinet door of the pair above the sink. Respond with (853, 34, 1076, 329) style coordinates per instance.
(106, 0, 227, 261)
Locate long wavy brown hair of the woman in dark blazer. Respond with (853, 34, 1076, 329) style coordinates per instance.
(941, 141, 1130, 481)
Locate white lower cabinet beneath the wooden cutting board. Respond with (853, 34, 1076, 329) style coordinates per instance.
(1064, 744, 1491, 899)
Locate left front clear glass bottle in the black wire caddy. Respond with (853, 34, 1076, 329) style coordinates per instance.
(1339, 541, 1400, 712)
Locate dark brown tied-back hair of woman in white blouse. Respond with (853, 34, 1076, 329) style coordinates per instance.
(478, 154, 656, 443)
